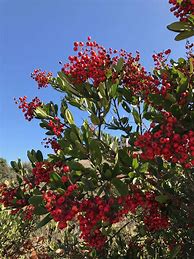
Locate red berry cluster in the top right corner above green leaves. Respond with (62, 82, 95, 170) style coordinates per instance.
(169, 0, 194, 22)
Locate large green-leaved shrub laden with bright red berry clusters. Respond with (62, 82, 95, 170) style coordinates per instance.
(0, 1, 194, 258)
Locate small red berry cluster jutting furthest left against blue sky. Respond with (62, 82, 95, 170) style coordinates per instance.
(14, 96, 42, 121)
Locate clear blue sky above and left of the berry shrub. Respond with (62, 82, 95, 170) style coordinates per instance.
(0, 0, 185, 164)
